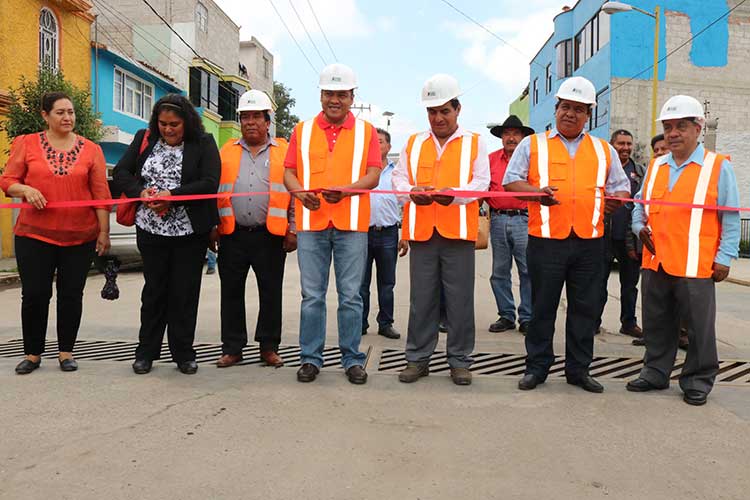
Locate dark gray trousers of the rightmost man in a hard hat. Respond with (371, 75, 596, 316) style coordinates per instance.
(641, 268, 719, 394)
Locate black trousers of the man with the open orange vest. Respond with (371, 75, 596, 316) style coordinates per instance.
(217, 229, 286, 354)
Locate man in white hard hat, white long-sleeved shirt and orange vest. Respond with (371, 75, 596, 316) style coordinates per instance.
(393, 74, 490, 385)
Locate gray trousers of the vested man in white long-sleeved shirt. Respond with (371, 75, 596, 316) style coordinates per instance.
(406, 230, 475, 368)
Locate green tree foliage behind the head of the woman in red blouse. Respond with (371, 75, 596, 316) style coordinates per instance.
(0, 69, 102, 142)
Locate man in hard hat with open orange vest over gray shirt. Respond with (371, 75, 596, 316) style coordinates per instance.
(211, 90, 297, 368)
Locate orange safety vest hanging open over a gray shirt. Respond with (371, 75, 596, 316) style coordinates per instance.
(216, 138, 291, 236)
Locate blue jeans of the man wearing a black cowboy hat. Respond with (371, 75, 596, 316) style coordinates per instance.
(490, 213, 531, 323)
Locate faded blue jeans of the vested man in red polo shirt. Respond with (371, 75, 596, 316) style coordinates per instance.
(297, 228, 367, 369)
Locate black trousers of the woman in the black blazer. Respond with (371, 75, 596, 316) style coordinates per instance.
(135, 228, 208, 363)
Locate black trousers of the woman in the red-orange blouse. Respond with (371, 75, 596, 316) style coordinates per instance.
(16, 236, 96, 356)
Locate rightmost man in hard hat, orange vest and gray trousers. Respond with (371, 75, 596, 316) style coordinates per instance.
(627, 95, 740, 406)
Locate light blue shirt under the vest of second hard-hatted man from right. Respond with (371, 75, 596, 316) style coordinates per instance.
(503, 128, 630, 194)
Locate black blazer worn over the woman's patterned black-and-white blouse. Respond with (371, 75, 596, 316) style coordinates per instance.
(112, 129, 221, 234)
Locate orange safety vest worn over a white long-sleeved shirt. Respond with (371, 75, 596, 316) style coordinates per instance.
(402, 132, 479, 241)
